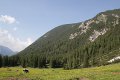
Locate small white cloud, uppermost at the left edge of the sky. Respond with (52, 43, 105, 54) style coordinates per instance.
(0, 15, 17, 24)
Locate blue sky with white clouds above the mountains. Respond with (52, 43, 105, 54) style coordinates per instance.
(0, 0, 120, 51)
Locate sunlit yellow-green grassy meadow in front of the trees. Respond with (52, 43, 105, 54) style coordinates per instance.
(0, 63, 120, 80)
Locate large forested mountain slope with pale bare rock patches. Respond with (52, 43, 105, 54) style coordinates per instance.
(13, 9, 120, 69)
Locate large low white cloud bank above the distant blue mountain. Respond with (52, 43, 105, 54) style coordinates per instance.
(0, 29, 33, 51)
